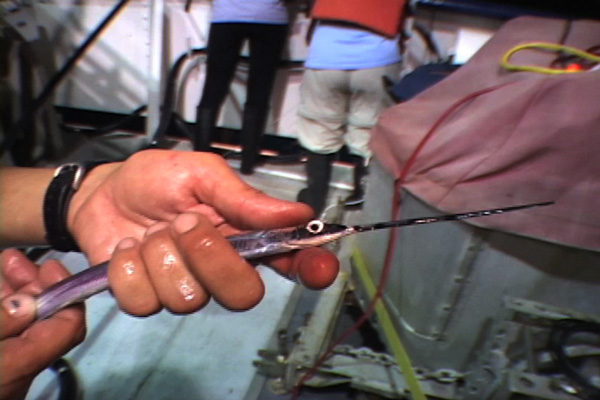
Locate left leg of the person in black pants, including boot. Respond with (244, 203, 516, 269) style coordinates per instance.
(194, 24, 244, 151)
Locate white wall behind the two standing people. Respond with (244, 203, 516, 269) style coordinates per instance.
(22, 0, 500, 136)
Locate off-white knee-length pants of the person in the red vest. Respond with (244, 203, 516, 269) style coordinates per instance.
(297, 63, 400, 158)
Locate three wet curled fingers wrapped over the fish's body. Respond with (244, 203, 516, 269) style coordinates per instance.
(108, 213, 252, 316)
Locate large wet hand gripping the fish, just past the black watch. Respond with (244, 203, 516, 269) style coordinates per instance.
(68, 150, 339, 315)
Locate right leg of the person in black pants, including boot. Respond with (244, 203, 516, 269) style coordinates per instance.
(240, 24, 287, 174)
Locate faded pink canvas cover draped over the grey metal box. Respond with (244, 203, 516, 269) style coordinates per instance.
(371, 17, 600, 250)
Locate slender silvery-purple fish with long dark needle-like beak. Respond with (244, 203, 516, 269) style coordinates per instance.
(36, 202, 553, 319)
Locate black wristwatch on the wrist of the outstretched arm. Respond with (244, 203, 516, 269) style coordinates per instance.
(43, 161, 107, 251)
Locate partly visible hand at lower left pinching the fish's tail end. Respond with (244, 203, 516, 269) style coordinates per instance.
(0, 249, 85, 400)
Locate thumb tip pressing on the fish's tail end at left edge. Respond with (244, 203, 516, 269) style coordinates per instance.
(0, 293, 36, 339)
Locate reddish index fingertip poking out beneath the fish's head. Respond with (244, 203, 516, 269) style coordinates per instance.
(269, 247, 340, 290)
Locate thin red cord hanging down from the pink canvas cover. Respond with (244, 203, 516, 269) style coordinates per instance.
(292, 83, 510, 400)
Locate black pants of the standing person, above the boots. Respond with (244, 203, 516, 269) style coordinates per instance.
(198, 23, 287, 111)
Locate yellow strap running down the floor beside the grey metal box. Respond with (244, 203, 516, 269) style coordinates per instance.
(352, 247, 427, 400)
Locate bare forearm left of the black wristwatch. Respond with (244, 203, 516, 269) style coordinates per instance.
(0, 167, 54, 247)
